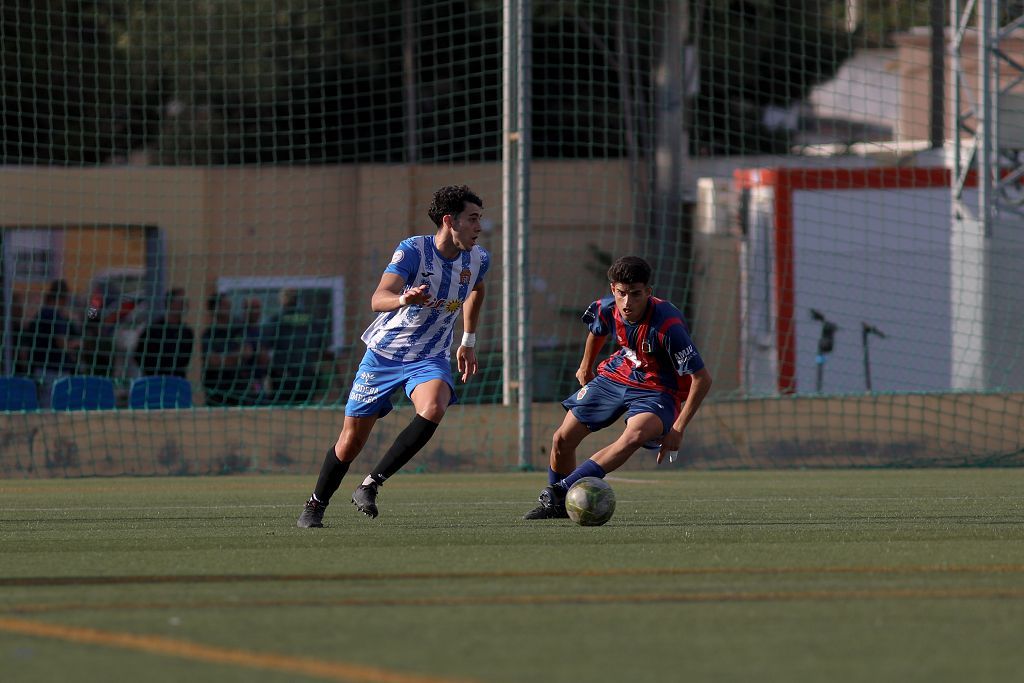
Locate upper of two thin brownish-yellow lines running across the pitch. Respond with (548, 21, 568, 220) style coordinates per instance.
(0, 564, 1024, 588)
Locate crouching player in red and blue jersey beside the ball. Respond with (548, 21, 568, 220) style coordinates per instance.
(524, 256, 712, 519)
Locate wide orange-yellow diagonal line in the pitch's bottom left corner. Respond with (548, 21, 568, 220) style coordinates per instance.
(0, 617, 477, 683)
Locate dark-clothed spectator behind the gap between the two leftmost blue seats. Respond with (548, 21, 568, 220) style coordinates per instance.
(18, 280, 81, 408)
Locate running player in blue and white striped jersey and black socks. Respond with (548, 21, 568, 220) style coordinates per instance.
(296, 185, 490, 528)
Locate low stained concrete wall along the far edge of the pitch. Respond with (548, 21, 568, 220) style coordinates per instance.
(0, 393, 1024, 481)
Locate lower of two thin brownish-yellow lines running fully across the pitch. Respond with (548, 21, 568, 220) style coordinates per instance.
(9, 588, 1024, 618)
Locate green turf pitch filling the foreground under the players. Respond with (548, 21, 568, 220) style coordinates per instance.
(0, 469, 1024, 683)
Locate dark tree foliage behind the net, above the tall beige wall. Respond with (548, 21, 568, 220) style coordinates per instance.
(2, 0, 872, 165)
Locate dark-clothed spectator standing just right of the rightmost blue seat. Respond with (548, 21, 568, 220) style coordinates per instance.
(202, 294, 254, 405)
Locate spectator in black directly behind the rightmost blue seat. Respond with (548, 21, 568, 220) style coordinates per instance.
(135, 287, 196, 379)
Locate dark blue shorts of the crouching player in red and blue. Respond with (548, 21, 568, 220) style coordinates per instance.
(562, 375, 679, 447)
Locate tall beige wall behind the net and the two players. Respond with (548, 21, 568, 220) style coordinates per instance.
(0, 161, 655, 400)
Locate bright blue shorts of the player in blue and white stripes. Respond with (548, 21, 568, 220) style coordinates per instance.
(345, 349, 458, 418)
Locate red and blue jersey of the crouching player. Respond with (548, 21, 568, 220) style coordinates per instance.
(583, 296, 705, 401)
